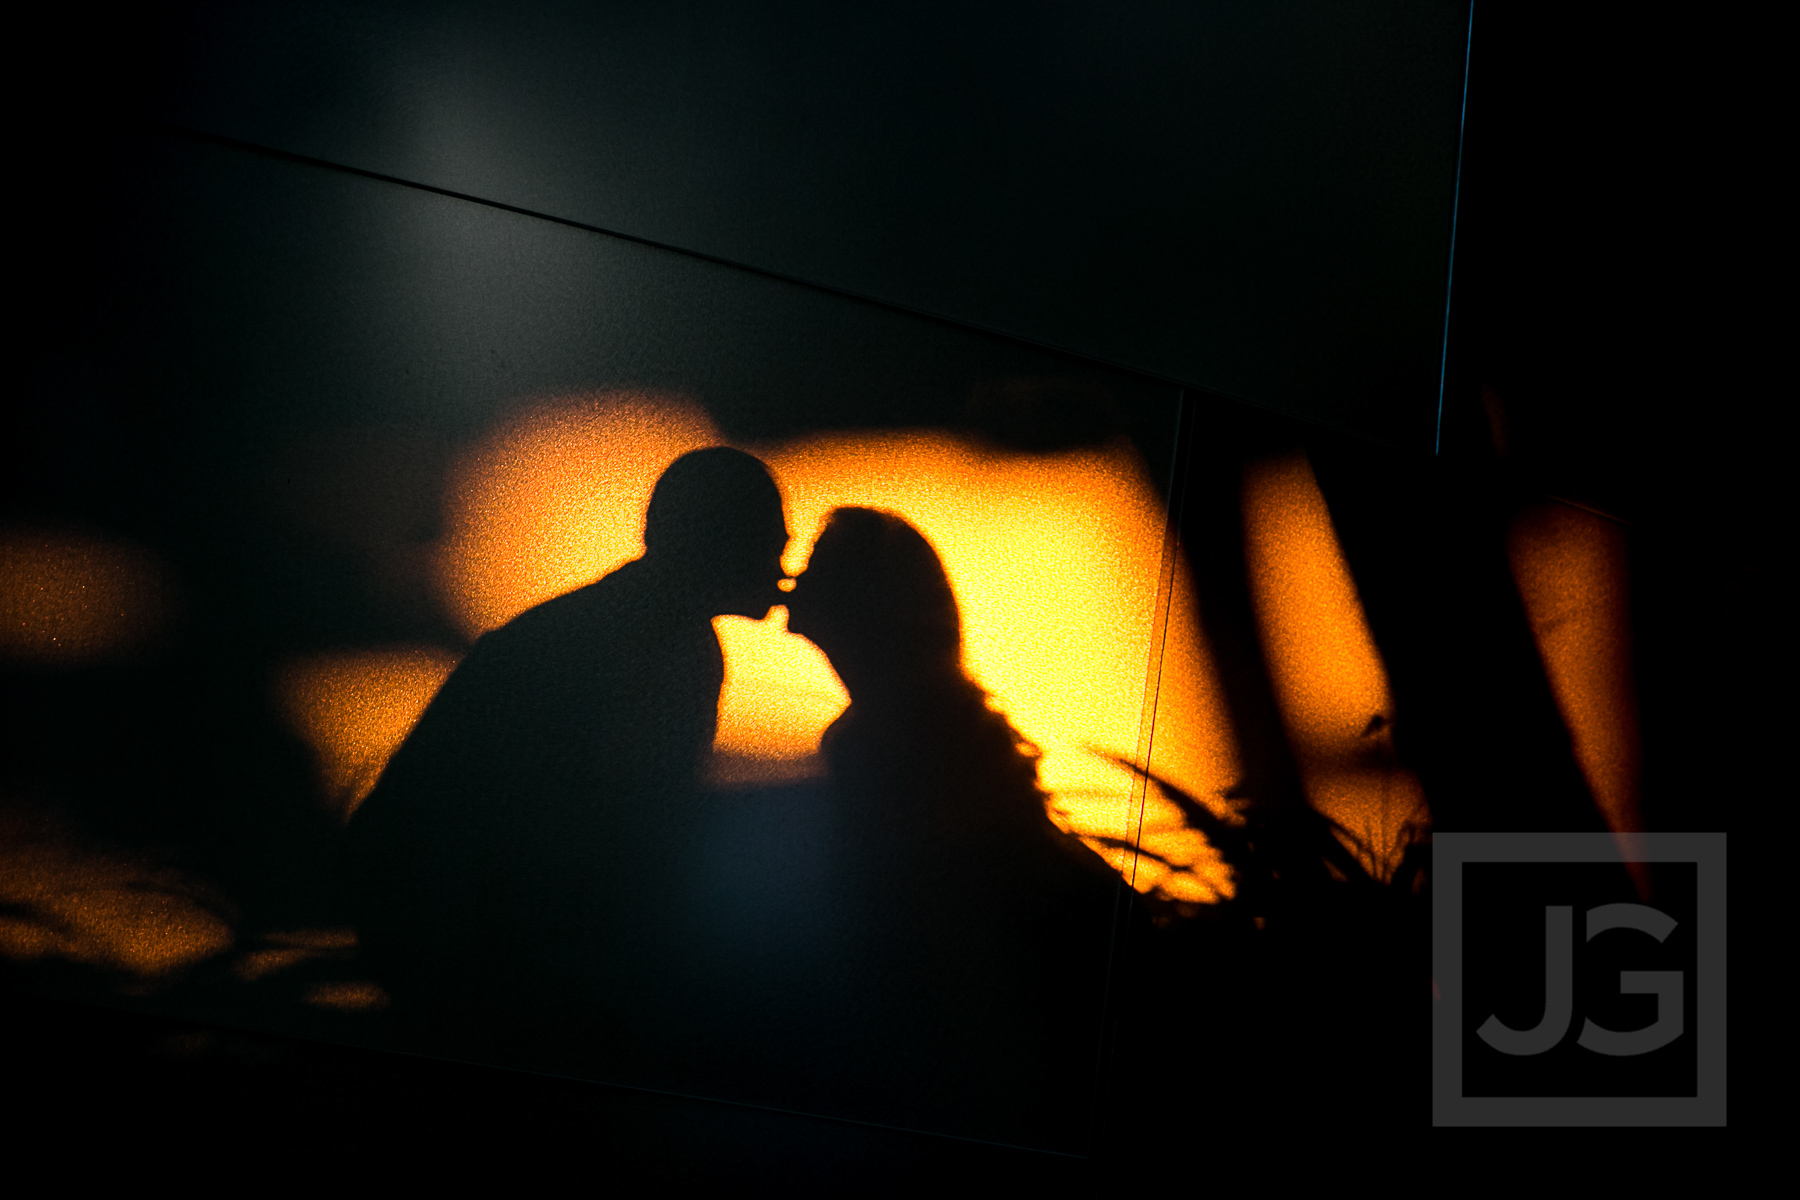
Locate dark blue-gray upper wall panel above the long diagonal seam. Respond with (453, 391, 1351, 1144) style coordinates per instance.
(149, 0, 1469, 448)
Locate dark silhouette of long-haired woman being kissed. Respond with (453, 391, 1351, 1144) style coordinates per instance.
(788, 507, 1118, 1146)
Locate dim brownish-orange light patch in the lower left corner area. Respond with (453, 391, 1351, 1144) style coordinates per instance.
(0, 811, 232, 984)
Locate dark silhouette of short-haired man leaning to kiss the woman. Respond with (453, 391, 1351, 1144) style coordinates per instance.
(349, 448, 788, 1052)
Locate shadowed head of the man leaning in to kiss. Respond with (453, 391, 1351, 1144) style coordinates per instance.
(644, 446, 788, 621)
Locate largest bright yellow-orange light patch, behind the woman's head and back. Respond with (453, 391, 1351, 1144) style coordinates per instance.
(751, 432, 1237, 901)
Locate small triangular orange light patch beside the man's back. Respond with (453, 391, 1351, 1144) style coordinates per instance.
(275, 646, 457, 820)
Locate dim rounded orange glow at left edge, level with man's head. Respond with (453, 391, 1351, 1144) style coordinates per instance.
(0, 529, 175, 666)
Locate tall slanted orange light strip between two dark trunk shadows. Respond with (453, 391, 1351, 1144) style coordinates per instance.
(1244, 453, 1426, 880)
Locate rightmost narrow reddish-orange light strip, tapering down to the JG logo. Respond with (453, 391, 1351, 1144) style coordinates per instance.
(1507, 504, 1643, 863)
